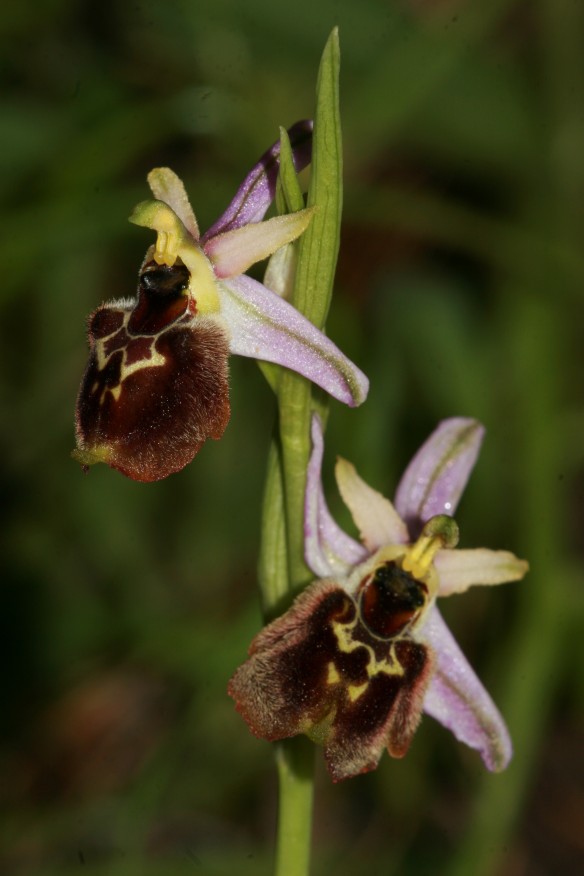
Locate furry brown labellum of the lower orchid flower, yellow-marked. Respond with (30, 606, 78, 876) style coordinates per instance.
(229, 562, 432, 781)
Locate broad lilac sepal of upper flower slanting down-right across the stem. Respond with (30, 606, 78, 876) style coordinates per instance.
(217, 274, 369, 407)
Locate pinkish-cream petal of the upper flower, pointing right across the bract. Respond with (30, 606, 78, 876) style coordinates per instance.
(204, 207, 314, 279)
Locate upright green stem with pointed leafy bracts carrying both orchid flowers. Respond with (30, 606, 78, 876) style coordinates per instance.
(259, 30, 342, 876)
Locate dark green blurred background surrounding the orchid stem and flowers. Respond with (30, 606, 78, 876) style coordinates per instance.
(0, 0, 584, 876)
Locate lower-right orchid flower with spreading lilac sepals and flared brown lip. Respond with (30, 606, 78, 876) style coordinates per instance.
(229, 417, 528, 781)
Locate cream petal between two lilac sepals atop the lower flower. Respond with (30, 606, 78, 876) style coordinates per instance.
(335, 458, 409, 553)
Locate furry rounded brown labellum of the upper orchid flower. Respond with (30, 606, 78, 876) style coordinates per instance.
(73, 260, 230, 481)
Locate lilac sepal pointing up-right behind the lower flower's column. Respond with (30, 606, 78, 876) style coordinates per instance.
(395, 417, 484, 538)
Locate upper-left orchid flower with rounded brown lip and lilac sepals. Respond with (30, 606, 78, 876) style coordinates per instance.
(73, 122, 368, 481)
